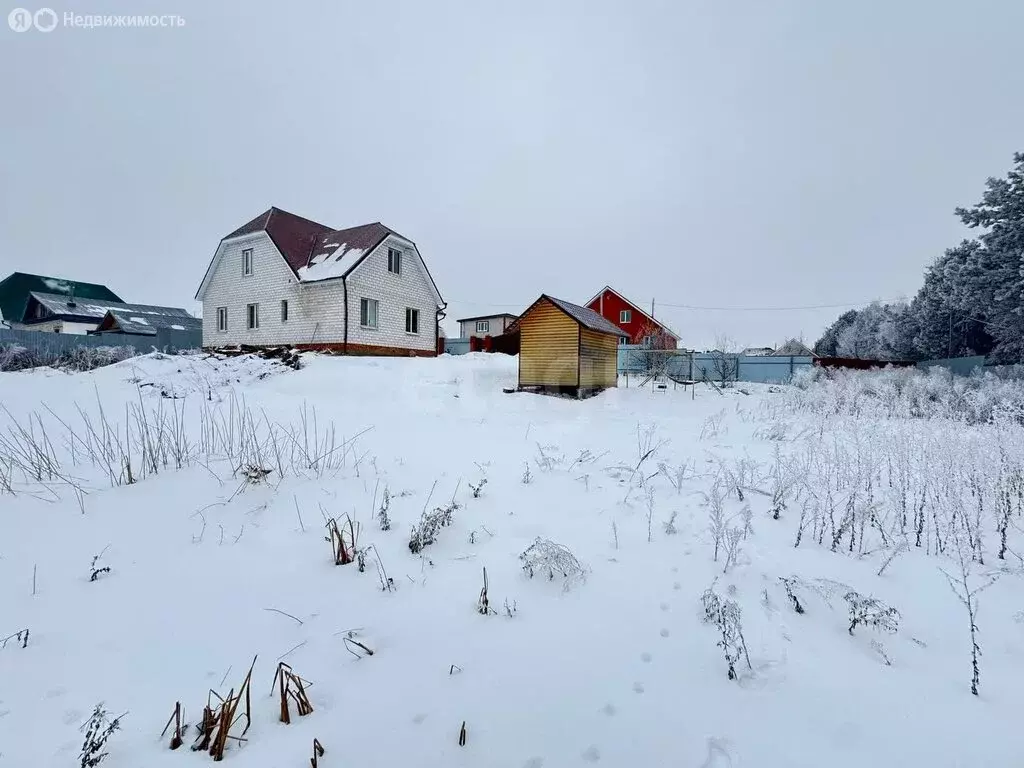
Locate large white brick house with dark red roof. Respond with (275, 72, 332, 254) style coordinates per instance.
(196, 208, 445, 355)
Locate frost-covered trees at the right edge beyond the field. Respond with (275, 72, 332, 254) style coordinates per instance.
(814, 153, 1024, 364)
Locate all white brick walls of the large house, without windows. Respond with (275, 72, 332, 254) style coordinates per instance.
(203, 231, 436, 354)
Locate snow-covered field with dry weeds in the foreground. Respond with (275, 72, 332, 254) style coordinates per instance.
(0, 354, 1024, 768)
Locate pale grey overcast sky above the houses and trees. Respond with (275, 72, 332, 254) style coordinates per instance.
(0, 0, 1024, 347)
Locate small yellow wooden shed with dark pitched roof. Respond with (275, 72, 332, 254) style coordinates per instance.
(515, 295, 625, 397)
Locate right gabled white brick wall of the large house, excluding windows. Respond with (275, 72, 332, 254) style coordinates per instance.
(348, 237, 437, 350)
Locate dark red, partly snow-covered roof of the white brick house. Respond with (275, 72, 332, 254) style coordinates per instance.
(204, 207, 444, 306)
